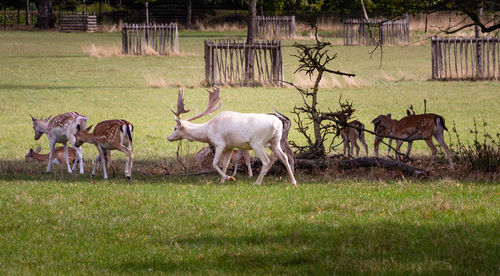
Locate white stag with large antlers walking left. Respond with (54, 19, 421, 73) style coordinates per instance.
(167, 87, 297, 185)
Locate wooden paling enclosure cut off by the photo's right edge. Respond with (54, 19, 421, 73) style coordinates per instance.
(431, 37, 500, 80)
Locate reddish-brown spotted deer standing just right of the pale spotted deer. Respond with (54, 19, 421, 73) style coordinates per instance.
(75, 120, 134, 180)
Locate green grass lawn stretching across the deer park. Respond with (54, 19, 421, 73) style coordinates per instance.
(0, 32, 500, 275)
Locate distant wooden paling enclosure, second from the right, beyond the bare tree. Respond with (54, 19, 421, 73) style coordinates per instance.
(344, 17, 410, 45)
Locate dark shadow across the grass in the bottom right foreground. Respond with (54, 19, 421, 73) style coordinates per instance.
(110, 221, 500, 274)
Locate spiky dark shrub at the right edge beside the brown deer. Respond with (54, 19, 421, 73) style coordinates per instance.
(451, 119, 500, 172)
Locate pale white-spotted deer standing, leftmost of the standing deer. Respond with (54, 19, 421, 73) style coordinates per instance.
(31, 112, 88, 174)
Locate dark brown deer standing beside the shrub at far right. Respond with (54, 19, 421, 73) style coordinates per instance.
(379, 113, 454, 170)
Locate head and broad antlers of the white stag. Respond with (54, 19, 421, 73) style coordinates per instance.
(167, 87, 221, 141)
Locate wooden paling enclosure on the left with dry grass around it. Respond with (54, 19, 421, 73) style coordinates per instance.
(122, 23, 179, 55)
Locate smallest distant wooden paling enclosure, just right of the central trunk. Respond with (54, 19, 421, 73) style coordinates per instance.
(255, 16, 295, 38)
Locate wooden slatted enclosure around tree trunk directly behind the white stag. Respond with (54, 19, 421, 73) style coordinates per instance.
(205, 40, 284, 86)
